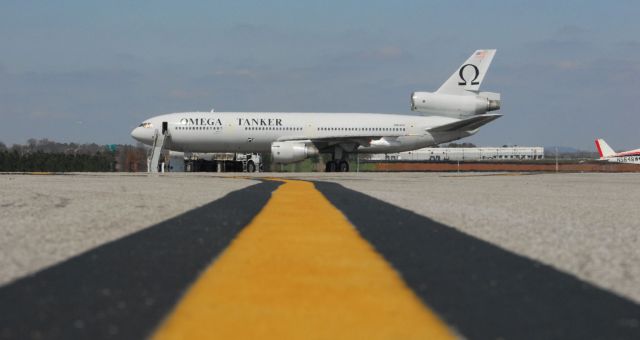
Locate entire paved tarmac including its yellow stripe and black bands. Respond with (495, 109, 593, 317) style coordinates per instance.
(0, 173, 640, 339)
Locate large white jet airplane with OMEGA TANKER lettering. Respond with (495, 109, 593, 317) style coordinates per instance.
(131, 50, 502, 172)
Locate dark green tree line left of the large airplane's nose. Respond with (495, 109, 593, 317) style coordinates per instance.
(0, 139, 147, 172)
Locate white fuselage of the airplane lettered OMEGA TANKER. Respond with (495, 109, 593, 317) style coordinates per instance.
(132, 112, 474, 153)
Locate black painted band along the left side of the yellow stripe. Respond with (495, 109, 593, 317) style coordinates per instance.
(0, 182, 280, 339)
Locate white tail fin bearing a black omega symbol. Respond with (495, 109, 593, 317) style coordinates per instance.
(435, 50, 496, 95)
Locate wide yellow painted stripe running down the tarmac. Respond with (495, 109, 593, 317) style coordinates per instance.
(153, 181, 455, 339)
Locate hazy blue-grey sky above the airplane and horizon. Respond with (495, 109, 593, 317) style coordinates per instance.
(0, 0, 640, 150)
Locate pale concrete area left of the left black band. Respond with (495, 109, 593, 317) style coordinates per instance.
(0, 174, 256, 284)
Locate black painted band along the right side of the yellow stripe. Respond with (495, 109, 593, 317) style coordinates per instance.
(316, 182, 640, 339)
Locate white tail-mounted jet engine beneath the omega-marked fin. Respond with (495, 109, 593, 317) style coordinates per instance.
(411, 92, 500, 118)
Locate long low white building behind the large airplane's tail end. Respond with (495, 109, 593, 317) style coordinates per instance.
(371, 146, 544, 162)
